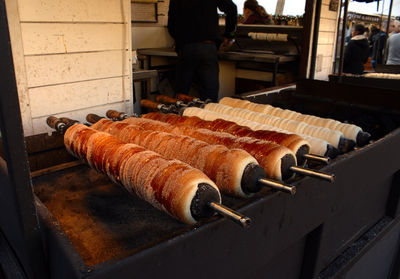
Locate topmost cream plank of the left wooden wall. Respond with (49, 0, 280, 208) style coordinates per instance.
(18, 0, 125, 23)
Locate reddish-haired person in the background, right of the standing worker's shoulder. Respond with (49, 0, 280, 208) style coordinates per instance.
(240, 0, 273, 24)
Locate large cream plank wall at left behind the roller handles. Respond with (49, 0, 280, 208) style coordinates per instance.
(6, 0, 132, 136)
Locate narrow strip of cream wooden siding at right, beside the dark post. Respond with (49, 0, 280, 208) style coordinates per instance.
(315, 0, 339, 80)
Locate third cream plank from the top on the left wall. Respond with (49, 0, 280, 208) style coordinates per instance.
(25, 51, 131, 88)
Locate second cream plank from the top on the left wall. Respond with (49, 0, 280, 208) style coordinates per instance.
(21, 23, 127, 55)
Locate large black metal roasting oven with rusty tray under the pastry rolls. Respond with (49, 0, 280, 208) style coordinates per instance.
(3, 81, 400, 278)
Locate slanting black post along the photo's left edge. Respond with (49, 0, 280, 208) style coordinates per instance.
(0, 0, 48, 278)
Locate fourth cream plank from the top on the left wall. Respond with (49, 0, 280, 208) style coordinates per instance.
(29, 77, 130, 118)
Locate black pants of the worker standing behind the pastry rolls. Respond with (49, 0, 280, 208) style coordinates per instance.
(176, 43, 219, 101)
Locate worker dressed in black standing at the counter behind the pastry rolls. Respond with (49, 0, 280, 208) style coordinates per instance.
(168, 0, 237, 101)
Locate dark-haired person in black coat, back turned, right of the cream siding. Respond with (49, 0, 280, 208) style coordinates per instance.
(343, 24, 369, 75)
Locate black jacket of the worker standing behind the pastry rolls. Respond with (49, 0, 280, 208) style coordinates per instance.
(168, 0, 237, 48)
